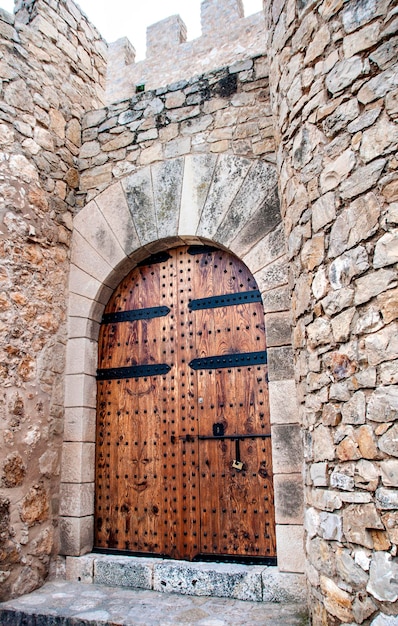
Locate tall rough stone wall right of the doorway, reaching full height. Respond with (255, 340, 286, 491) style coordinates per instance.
(267, 0, 398, 626)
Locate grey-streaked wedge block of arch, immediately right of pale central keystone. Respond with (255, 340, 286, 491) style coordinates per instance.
(196, 155, 251, 238)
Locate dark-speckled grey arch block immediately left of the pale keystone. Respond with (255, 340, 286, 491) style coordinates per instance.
(151, 158, 184, 239)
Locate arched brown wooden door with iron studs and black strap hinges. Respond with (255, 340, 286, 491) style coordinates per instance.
(95, 246, 276, 560)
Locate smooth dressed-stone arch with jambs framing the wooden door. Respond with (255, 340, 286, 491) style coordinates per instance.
(60, 155, 304, 572)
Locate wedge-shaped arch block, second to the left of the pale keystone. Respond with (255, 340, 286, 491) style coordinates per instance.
(122, 167, 158, 245)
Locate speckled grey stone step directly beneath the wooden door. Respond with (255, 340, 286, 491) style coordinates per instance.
(66, 553, 306, 605)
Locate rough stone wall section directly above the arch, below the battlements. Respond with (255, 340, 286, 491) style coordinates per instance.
(79, 56, 275, 205)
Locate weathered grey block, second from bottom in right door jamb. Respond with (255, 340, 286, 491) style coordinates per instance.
(274, 474, 304, 524)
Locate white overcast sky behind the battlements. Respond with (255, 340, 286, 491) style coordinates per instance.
(0, 0, 262, 61)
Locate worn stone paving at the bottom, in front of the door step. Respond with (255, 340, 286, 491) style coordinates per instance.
(0, 581, 309, 626)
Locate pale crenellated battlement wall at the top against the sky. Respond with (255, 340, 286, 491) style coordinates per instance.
(107, 0, 266, 104)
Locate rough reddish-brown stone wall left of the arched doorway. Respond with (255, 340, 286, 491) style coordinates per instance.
(0, 0, 106, 598)
